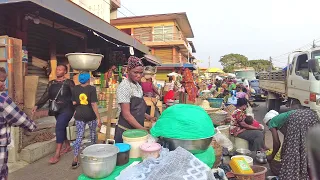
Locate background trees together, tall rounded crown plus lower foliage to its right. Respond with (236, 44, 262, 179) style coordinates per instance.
(219, 53, 270, 73)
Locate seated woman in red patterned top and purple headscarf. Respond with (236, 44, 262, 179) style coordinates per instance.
(230, 98, 266, 151)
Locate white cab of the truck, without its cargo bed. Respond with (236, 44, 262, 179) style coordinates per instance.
(286, 47, 320, 109)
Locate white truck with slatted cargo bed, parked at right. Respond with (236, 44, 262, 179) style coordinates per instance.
(259, 47, 320, 112)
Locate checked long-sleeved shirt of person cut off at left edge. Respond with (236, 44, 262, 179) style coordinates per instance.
(0, 93, 36, 146)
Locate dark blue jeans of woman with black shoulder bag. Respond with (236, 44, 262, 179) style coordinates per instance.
(55, 112, 73, 144)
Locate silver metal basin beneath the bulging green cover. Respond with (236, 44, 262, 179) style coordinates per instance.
(159, 137, 213, 154)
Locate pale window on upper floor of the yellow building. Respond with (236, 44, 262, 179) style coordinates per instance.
(153, 26, 173, 41)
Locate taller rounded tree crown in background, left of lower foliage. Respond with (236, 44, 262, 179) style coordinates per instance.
(219, 53, 248, 72)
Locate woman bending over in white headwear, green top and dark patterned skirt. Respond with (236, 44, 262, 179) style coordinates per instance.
(264, 109, 320, 180)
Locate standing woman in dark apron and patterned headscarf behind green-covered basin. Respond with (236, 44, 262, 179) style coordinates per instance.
(115, 56, 156, 143)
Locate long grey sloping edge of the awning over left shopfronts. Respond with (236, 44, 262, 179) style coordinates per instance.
(0, 0, 149, 54)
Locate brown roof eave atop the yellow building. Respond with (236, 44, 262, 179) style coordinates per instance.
(111, 12, 194, 38)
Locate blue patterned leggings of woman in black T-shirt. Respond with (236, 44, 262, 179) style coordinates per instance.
(73, 120, 97, 156)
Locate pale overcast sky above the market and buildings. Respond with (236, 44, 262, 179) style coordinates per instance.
(118, 0, 320, 68)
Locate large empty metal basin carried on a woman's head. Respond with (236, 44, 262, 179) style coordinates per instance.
(66, 53, 104, 71)
